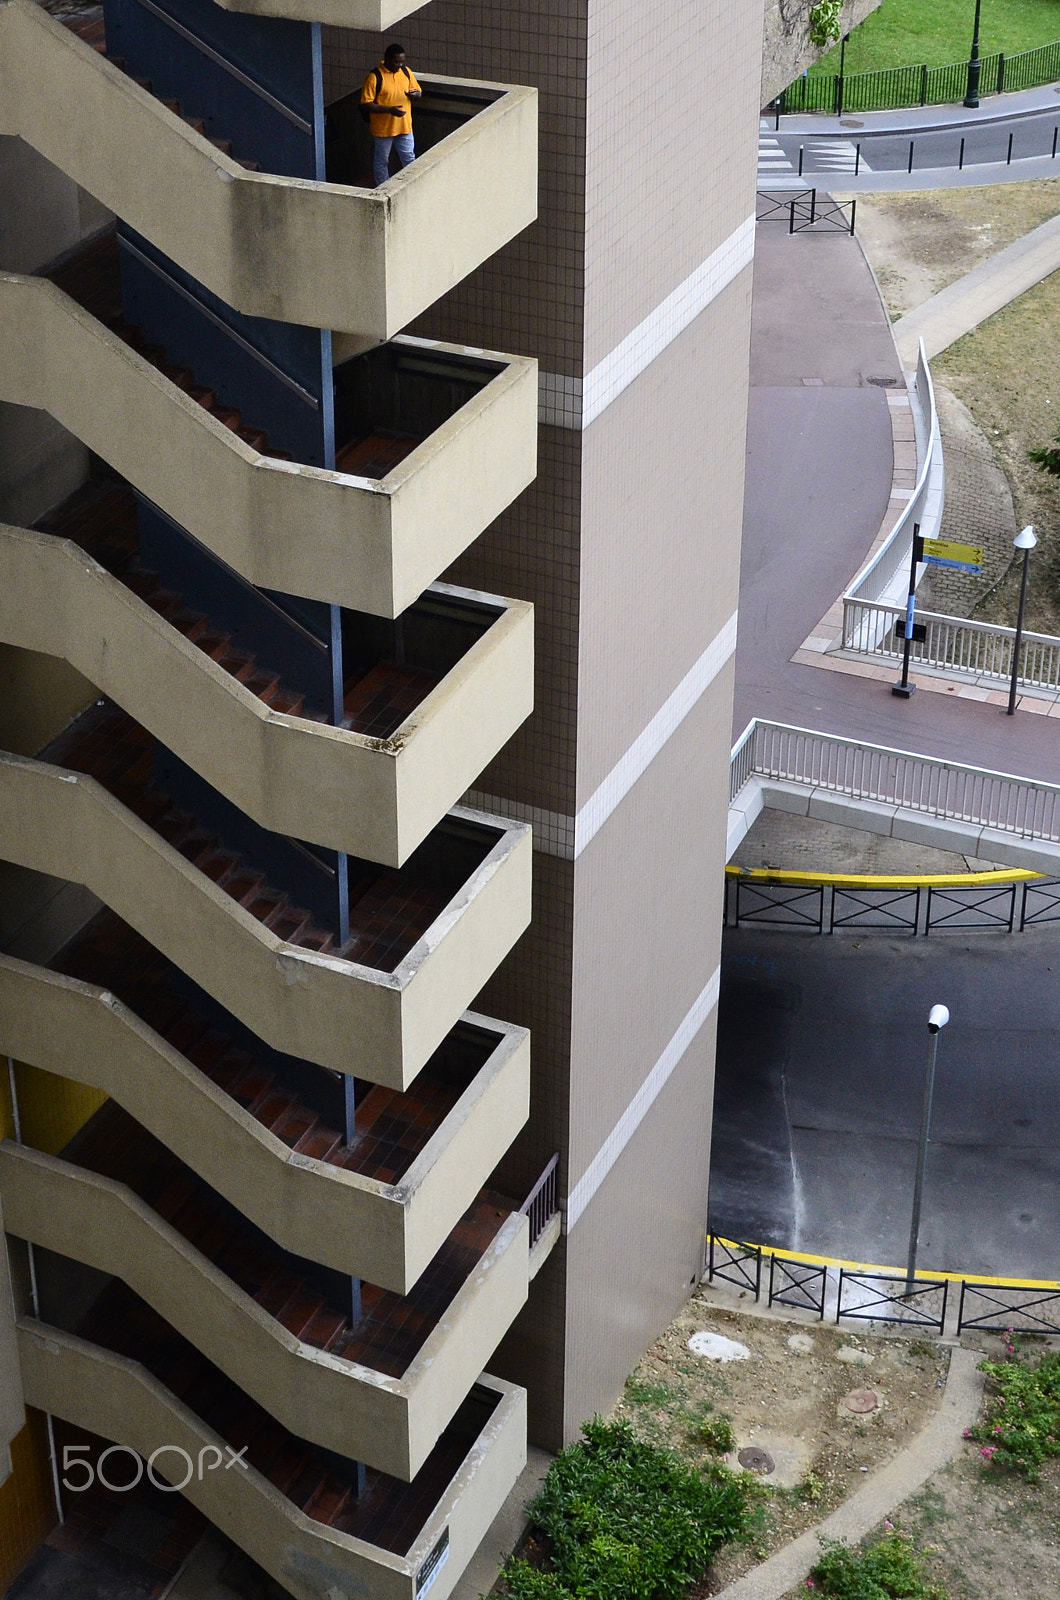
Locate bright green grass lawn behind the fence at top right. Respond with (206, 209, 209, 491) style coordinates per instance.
(812, 0, 1060, 75)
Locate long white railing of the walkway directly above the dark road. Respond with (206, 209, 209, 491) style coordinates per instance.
(730, 718, 1060, 843)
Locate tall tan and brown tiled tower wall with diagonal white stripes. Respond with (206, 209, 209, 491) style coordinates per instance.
(325, 0, 762, 1446)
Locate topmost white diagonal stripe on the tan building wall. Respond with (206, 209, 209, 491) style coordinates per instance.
(581, 216, 754, 427)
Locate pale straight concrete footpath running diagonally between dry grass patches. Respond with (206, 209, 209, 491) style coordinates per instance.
(893, 216, 1060, 368)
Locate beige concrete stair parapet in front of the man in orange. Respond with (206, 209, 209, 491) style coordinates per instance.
(0, 0, 536, 339)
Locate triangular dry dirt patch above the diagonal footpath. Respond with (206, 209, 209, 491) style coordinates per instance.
(858, 180, 1060, 320)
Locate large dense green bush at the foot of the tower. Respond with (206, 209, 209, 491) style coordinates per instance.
(503, 1419, 748, 1600)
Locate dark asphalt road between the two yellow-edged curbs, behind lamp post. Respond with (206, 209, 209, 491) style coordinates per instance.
(711, 928, 1060, 1278)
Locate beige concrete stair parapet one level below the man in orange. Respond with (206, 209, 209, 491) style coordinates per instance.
(0, 278, 538, 616)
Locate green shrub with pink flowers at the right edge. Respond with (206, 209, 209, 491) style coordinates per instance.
(964, 1344, 1060, 1483)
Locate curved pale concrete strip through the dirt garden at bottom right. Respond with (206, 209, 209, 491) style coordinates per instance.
(716, 1349, 985, 1600)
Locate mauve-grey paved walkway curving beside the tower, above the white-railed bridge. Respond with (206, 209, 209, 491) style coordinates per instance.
(733, 212, 1060, 782)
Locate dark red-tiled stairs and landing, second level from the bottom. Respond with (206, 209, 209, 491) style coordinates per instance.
(64, 1102, 512, 1378)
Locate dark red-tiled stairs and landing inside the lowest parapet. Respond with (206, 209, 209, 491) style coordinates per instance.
(77, 1280, 499, 1555)
